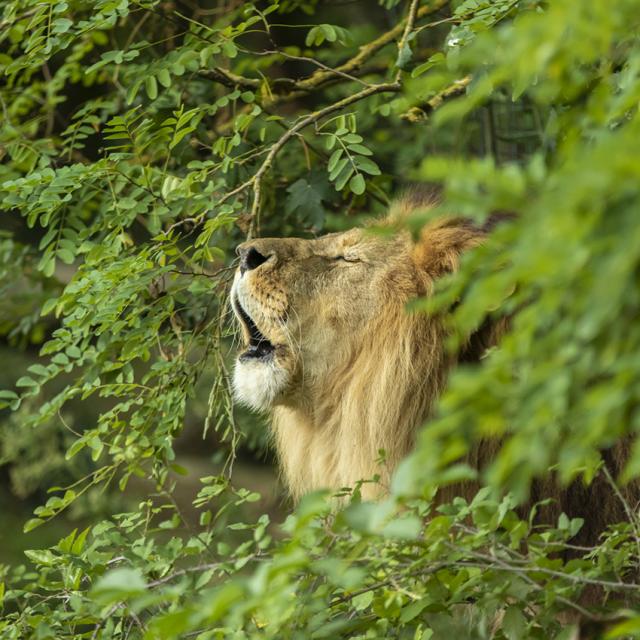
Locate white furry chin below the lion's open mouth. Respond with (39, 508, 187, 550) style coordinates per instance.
(233, 355, 290, 411)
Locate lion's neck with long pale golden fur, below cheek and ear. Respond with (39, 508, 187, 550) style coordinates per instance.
(273, 315, 443, 499)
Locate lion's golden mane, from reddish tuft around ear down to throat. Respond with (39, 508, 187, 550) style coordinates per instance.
(273, 195, 485, 499)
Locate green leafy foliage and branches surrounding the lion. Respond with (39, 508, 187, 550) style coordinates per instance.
(0, 0, 640, 640)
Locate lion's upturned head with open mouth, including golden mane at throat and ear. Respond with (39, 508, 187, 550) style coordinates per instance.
(231, 195, 483, 496)
